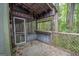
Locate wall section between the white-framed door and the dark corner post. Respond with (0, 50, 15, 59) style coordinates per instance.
(26, 21, 36, 42)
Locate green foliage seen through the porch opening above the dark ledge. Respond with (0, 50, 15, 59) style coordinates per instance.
(38, 17, 51, 31)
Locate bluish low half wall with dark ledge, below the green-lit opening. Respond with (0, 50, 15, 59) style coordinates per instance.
(36, 31, 52, 44)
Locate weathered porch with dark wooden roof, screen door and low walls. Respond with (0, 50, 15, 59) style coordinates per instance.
(9, 3, 79, 56)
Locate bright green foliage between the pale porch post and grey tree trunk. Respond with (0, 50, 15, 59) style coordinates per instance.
(58, 4, 68, 32)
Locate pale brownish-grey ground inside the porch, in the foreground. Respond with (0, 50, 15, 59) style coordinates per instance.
(15, 41, 71, 56)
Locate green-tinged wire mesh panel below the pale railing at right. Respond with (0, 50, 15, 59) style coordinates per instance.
(53, 33, 79, 55)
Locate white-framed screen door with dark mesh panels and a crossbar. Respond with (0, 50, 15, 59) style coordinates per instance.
(13, 17, 26, 44)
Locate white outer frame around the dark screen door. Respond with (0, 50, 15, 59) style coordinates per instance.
(13, 17, 26, 45)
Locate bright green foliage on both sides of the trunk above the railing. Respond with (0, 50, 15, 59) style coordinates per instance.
(58, 4, 79, 33)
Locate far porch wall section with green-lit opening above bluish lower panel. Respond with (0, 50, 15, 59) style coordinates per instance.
(36, 17, 52, 44)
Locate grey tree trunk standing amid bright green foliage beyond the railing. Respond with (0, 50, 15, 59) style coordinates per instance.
(67, 3, 75, 32)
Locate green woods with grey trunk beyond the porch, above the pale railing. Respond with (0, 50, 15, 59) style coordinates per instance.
(59, 4, 79, 33)
